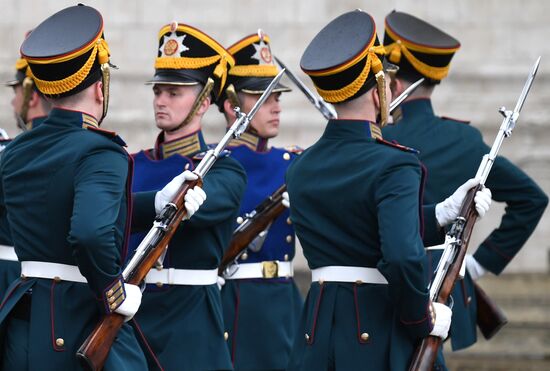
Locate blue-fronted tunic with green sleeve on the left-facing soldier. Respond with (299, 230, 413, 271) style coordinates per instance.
(131, 131, 246, 370)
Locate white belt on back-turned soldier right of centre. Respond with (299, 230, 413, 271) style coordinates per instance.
(311, 265, 388, 285)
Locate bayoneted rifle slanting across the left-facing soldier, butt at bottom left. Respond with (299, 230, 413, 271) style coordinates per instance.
(76, 69, 284, 371)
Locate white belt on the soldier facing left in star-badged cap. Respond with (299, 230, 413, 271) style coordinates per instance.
(145, 268, 218, 286)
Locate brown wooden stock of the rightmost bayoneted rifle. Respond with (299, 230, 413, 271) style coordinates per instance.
(409, 185, 482, 371)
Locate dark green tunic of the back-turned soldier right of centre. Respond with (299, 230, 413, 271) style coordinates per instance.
(286, 120, 435, 370)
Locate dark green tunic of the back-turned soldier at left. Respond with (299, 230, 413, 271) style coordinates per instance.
(0, 109, 148, 370)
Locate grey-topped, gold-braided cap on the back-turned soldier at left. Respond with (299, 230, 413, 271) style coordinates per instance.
(21, 4, 109, 97)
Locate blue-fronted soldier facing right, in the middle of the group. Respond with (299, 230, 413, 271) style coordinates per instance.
(218, 30, 302, 370)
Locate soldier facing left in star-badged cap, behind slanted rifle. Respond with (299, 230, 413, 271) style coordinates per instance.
(132, 22, 246, 370)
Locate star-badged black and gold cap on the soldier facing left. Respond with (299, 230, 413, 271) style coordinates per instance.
(148, 22, 235, 97)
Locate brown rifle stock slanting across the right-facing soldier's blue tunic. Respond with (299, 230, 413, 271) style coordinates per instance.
(218, 184, 286, 276)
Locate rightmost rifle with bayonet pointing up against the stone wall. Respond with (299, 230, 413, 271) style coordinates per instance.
(409, 57, 540, 371)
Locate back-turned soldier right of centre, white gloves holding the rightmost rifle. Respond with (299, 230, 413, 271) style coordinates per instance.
(286, 10, 494, 370)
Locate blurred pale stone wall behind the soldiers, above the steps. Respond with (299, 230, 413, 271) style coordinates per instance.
(0, 0, 550, 272)
